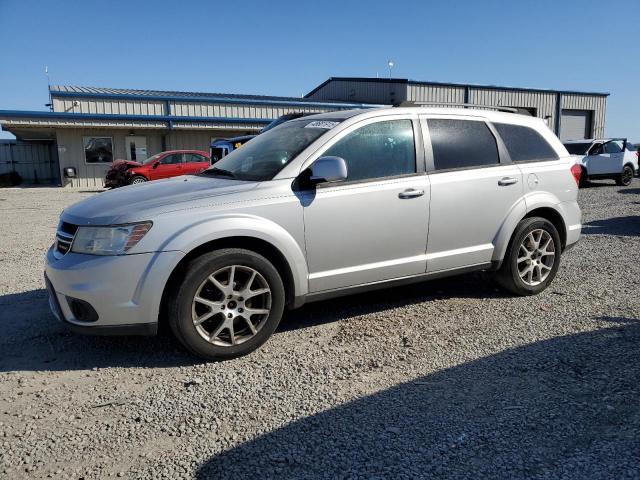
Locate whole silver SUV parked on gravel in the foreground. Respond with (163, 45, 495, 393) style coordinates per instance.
(45, 108, 581, 359)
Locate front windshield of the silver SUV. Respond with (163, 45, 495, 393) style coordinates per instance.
(202, 120, 339, 181)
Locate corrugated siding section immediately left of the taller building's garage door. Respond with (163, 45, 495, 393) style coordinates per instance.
(469, 87, 556, 130)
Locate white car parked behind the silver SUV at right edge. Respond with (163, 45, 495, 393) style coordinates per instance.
(564, 138, 639, 185)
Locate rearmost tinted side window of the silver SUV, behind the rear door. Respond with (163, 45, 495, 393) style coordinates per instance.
(493, 123, 559, 162)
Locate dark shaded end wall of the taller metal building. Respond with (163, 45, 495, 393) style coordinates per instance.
(308, 80, 407, 104)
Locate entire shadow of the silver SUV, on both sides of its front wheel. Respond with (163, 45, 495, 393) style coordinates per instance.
(0, 273, 506, 372)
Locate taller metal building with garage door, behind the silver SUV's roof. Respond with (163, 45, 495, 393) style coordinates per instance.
(305, 77, 609, 140)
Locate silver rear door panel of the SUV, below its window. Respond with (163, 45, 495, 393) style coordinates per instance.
(427, 165, 523, 272)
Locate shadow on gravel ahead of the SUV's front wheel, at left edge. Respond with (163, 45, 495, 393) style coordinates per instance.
(0, 289, 196, 372)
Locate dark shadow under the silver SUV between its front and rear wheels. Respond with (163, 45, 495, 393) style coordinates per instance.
(278, 272, 511, 331)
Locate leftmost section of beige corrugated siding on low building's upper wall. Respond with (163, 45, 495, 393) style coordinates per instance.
(53, 97, 168, 115)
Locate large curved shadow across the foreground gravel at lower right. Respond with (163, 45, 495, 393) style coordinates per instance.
(196, 318, 640, 479)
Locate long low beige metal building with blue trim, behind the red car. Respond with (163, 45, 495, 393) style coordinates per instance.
(0, 86, 378, 187)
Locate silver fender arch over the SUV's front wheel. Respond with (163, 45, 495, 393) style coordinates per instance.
(155, 213, 308, 297)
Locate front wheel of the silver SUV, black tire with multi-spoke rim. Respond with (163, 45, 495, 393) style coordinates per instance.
(168, 248, 285, 360)
